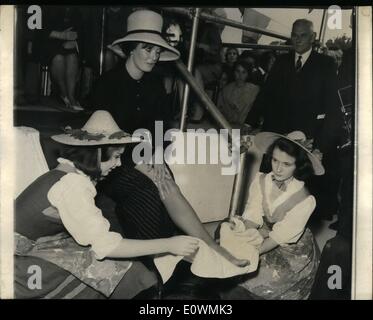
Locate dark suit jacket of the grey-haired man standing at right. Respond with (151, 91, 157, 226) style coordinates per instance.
(247, 52, 342, 152)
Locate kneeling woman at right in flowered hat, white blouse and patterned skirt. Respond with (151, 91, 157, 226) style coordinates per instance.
(221, 131, 324, 300)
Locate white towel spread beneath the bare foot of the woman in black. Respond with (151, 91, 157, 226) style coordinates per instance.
(154, 236, 257, 283)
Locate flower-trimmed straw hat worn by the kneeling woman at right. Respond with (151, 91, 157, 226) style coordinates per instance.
(254, 131, 325, 176)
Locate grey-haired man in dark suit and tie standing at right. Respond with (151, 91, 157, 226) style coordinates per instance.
(246, 19, 343, 220)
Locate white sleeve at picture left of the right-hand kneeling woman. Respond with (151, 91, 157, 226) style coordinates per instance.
(242, 172, 264, 227)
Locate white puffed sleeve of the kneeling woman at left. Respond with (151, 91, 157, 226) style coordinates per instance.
(48, 173, 122, 260)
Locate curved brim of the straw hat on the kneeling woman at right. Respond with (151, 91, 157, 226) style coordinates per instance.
(254, 132, 325, 176)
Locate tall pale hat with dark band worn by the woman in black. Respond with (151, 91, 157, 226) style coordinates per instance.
(112, 10, 180, 61)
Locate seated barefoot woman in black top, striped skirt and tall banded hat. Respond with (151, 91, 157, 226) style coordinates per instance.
(88, 9, 247, 266)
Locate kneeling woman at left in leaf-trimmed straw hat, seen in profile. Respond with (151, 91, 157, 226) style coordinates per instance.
(15, 111, 198, 299)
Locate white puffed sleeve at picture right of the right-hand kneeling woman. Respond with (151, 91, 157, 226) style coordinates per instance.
(269, 196, 316, 245)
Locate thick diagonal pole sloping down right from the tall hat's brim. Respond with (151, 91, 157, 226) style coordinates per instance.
(175, 59, 232, 138)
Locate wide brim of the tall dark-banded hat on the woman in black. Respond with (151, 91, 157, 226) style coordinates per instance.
(111, 32, 180, 61)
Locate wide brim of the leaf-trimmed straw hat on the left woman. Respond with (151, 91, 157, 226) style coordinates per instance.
(51, 133, 143, 146)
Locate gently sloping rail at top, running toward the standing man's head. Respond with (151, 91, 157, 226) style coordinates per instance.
(163, 7, 290, 40)
